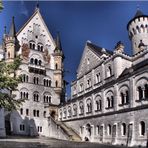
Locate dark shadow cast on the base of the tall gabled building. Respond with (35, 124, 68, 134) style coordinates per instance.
(5, 111, 39, 137)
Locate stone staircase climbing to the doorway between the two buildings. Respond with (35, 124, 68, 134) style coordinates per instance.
(55, 121, 82, 141)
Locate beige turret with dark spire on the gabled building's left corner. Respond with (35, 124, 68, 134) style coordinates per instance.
(4, 17, 20, 62)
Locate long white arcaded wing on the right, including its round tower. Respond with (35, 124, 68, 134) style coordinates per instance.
(59, 10, 148, 146)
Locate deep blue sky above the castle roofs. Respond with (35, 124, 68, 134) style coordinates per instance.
(0, 1, 148, 94)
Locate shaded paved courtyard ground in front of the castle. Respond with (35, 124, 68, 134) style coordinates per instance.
(0, 137, 141, 148)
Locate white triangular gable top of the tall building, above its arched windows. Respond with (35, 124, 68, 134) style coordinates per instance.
(17, 9, 55, 53)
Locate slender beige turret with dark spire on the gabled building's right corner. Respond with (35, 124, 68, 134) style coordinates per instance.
(53, 33, 64, 102)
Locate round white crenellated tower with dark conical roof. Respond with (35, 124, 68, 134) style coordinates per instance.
(127, 9, 148, 54)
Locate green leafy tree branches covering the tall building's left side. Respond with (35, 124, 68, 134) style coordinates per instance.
(0, 57, 24, 110)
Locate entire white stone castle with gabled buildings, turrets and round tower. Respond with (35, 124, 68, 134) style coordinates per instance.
(0, 4, 148, 146)
